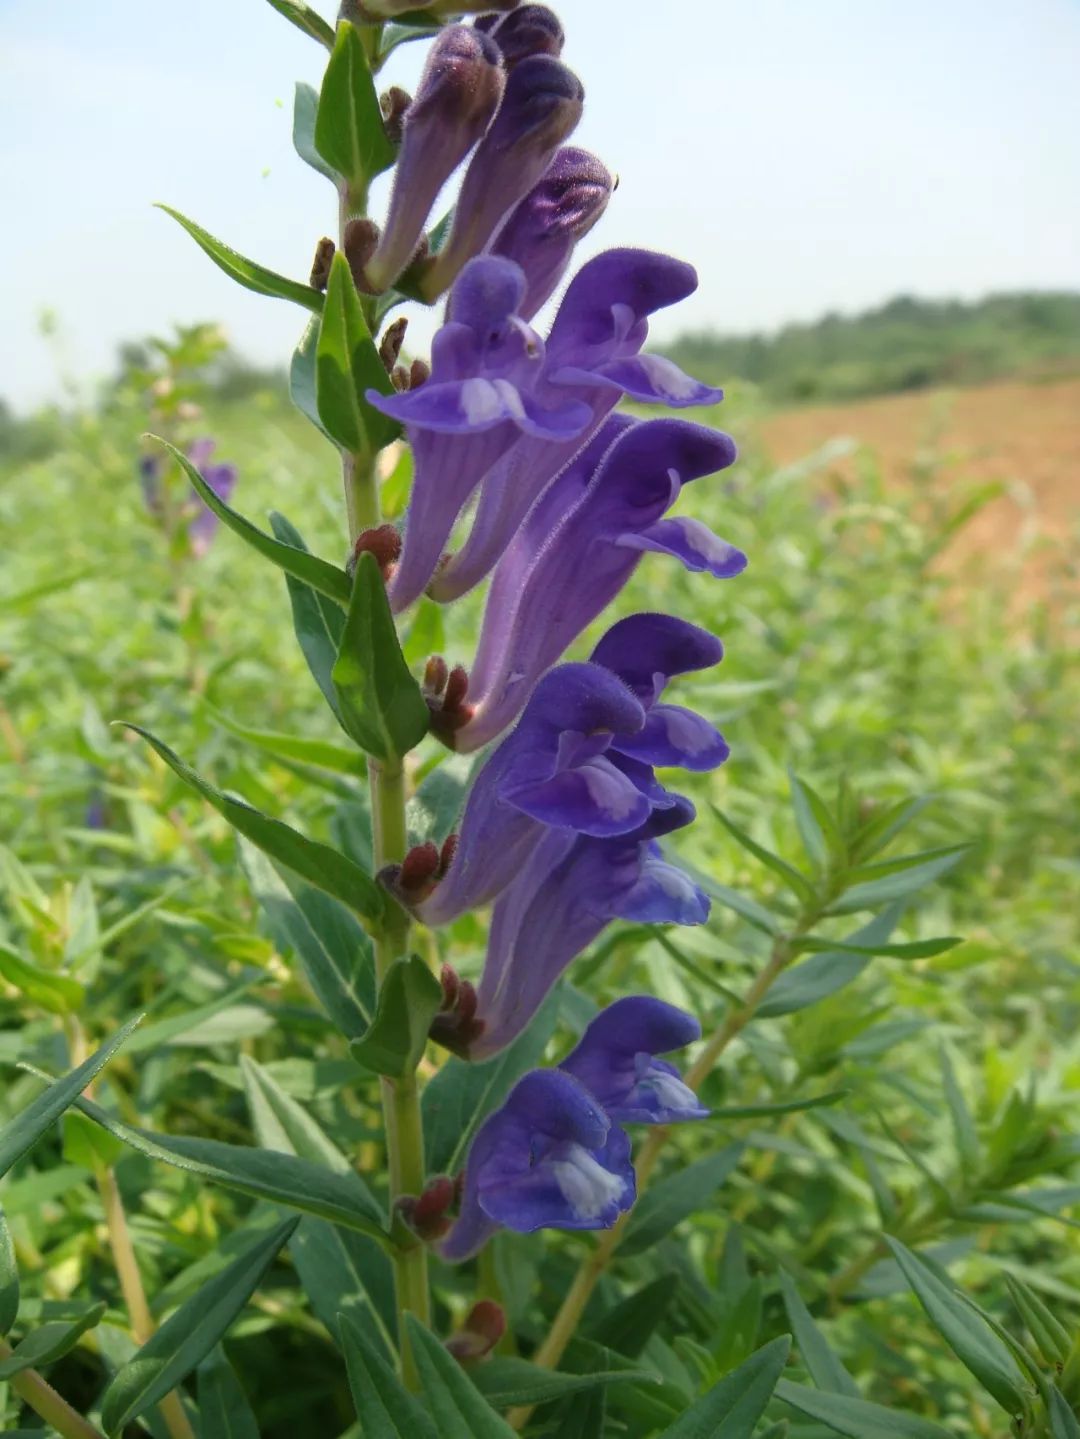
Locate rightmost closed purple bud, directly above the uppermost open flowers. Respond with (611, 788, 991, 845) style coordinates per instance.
(492, 147, 614, 319)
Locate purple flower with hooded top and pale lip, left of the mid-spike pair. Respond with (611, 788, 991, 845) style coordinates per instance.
(399, 665, 651, 925)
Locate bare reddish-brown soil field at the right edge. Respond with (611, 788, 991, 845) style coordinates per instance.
(761, 378, 1080, 596)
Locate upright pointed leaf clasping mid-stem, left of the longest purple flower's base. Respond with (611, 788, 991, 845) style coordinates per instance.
(332, 553, 429, 763)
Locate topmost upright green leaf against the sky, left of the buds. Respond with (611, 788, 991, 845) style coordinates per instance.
(315, 22, 395, 194)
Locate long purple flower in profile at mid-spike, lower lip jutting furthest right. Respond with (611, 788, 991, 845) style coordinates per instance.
(450, 417, 746, 753)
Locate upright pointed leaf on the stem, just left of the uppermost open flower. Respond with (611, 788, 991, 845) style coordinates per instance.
(315, 252, 400, 458)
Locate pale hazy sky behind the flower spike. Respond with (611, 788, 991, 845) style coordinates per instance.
(0, 0, 1080, 407)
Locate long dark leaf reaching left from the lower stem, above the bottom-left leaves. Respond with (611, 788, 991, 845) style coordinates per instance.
(69, 1099, 393, 1248)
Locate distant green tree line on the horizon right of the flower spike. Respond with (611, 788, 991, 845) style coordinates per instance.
(667, 291, 1080, 403)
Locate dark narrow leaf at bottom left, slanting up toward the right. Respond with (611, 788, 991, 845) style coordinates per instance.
(101, 1219, 299, 1439)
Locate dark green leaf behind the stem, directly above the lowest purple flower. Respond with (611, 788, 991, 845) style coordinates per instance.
(420, 990, 561, 1174)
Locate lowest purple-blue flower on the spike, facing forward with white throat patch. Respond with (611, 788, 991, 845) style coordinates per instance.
(441, 1069, 636, 1259)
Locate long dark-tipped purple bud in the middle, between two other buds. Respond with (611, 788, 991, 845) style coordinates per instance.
(420, 56, 585, 301)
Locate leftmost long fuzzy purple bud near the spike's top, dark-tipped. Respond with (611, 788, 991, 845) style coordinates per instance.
(367, 24, 505, 291)
